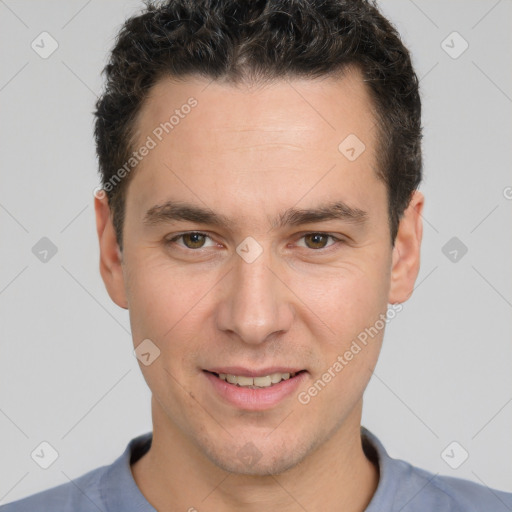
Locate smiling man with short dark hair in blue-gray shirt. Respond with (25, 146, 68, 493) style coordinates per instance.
(1, 0, 512, 512)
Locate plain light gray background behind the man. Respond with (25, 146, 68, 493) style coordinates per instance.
(0, 0, 512, 504)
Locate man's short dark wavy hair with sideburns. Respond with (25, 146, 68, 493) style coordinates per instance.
(94, 0, 422, 250)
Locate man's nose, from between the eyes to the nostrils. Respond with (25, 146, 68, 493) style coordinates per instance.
(217, 242, 294, 345)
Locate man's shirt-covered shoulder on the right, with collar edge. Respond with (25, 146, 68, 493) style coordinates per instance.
(362, 427, 512, 512)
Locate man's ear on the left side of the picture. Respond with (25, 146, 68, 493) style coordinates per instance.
(94, 193, 128, 309)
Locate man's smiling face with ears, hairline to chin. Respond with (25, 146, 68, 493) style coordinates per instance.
(96, 70, 421, 474)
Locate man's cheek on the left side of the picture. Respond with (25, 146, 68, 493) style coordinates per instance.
(125, 258, 208, 406)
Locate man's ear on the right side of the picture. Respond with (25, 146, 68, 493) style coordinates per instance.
(388, 190, 424, 304)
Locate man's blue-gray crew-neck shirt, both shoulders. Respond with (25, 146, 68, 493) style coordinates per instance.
(0, 427, 512, 512)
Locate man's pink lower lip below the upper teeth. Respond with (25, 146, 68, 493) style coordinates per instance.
(203, 371, 307, 411)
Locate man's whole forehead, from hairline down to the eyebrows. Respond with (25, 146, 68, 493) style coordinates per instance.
(127, 69, 378, 222)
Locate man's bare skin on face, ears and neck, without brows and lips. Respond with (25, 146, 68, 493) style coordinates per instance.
(95, 65, 423, 512)
